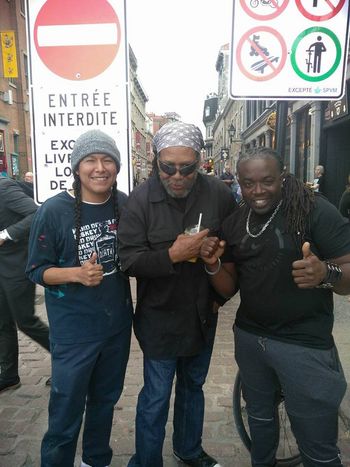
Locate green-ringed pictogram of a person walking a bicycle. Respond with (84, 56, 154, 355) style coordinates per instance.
(291, 27, 342, 82)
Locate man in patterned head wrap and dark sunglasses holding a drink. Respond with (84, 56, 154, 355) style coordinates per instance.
(119, 122, 236, 467)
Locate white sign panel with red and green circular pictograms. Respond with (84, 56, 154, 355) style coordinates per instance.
(230, 0, 349, 100)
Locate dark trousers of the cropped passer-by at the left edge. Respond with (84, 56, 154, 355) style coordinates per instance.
(0, 275, 50, 382)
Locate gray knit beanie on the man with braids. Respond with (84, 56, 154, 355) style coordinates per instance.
(71, 130, 120, 172)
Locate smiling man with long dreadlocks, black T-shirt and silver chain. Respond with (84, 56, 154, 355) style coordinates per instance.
(201, 148, 350, 467)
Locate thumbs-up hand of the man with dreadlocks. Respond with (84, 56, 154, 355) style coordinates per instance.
(292, 242, 327, 289)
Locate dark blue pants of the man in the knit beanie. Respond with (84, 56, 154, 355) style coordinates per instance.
(41, 327, 131, 467)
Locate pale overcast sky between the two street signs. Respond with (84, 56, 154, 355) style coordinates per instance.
(126, 0, 233, 130)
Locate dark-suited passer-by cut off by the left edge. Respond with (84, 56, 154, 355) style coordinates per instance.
(0, 177, 50, 392)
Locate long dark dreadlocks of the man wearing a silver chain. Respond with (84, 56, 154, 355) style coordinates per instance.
(237, 147, 315, 242)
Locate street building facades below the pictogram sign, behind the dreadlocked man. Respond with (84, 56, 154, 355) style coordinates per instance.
(203, 46, 350, 206)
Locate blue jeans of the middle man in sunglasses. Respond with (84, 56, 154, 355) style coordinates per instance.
(128, 343, 213, 467)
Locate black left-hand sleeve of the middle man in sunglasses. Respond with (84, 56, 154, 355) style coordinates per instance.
(118, 193, 176, 278)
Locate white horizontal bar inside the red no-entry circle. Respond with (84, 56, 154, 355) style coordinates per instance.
(38, 23, 118, 47)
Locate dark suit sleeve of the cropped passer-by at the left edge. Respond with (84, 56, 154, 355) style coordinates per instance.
(2, 183, 38, 242)
